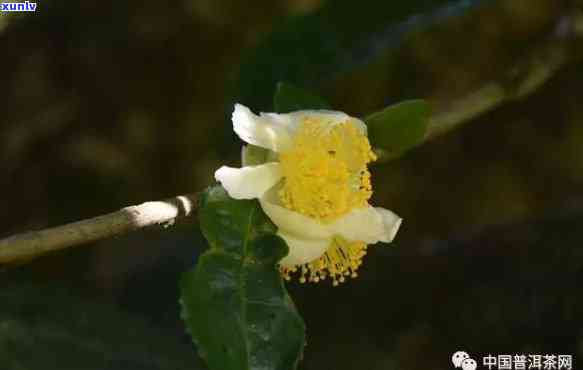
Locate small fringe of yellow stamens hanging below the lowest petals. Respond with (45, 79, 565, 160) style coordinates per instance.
(280, 236, 367, 286)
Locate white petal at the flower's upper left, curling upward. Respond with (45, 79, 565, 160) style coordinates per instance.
(232, 104, 292, 152)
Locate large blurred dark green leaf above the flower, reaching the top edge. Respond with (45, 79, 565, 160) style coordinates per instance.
(236, 0, 482, 111)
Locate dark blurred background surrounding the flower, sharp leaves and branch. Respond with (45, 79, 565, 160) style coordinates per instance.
(0, 0, 583, 370)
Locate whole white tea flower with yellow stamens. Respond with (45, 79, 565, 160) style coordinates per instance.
(215, 104, 402, 285)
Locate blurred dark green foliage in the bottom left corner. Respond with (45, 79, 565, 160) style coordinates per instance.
(0, 273, 204, 370)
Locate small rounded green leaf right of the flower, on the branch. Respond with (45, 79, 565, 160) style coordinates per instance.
(364, 100, 430, 159)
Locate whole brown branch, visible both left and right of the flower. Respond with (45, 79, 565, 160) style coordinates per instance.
(0, 12, 583, 264)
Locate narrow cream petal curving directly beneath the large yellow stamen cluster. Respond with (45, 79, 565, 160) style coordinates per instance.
(259, 187, 332, 239)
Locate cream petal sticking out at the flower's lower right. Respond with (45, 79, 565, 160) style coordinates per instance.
(328, 206, 401, 244)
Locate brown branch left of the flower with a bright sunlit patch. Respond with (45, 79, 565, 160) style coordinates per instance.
(0, 194, 197, 264)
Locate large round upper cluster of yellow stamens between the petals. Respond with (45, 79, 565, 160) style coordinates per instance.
(279, 117, 376, 222)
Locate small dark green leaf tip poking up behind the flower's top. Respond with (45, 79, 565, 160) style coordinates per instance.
(273, 82, 330, 113)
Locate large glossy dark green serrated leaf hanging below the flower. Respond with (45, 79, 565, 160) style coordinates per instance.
(181, 186, 305, 370)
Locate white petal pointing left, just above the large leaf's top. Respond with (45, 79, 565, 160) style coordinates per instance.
(215, 162, 281, 199)
